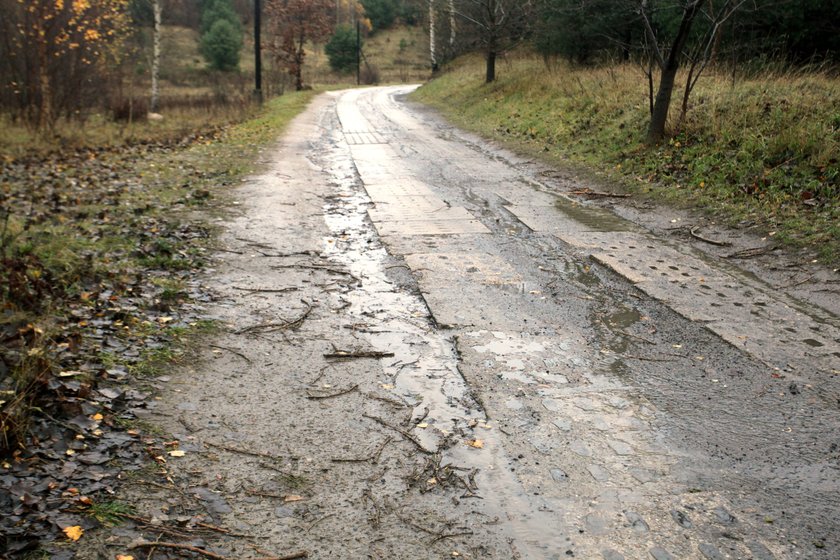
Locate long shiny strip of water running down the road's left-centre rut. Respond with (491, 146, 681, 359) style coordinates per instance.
(324, 135, 568, 558)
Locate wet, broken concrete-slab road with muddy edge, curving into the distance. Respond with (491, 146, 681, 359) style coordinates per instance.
(109, 87, 840, 560)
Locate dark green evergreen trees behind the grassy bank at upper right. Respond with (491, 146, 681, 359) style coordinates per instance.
(532, 0, 840, 64)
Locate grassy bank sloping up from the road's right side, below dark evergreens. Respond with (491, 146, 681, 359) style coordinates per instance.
(415, 55, 840, 265)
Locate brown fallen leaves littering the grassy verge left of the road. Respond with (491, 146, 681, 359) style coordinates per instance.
(0, 141, 220, 558)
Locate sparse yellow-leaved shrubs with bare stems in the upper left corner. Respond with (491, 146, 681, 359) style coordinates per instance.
(0, 0, 128, 130)
